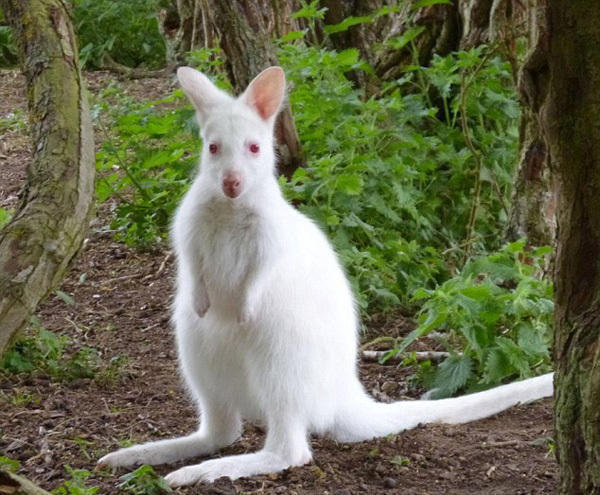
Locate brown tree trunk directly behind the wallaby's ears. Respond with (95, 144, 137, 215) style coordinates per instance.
(204, 0, 303, 177)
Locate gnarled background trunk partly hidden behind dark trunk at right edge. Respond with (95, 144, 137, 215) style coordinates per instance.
(507, 0, 556, 246)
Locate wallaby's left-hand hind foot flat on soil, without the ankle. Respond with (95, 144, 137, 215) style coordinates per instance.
(96, 433, 217, 469)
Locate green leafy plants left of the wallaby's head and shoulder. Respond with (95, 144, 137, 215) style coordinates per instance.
(96, 92, 199, 247)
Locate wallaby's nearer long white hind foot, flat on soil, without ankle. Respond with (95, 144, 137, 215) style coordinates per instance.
(165, 450, 311, 487)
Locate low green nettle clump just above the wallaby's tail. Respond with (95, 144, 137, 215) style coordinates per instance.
(394, 240, 554, 397)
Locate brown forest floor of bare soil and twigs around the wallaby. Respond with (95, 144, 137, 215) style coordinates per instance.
(0, 71, 557, 495)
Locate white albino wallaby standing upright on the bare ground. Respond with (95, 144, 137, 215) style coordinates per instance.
(98, 67, 552, 486)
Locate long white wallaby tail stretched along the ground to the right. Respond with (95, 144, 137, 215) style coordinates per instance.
(333, 373, 554, 442)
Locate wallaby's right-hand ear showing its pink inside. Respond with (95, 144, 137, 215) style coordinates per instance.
(240, 67, 285, 121)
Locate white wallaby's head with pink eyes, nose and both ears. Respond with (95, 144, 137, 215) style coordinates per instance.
(177, 67, 285, 200)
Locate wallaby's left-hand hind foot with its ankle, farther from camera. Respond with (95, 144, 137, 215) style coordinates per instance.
(98, 404, 242, 468)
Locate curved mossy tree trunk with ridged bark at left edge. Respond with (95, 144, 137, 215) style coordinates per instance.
(0, 0, 94, 355)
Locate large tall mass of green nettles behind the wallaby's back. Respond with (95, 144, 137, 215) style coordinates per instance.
(279, 43, 519, 309)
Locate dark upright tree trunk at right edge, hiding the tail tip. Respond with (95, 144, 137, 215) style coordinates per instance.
(540, 0, 600, 495)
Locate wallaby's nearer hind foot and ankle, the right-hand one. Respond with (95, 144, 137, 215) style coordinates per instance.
(165, 414, 311, 486)
